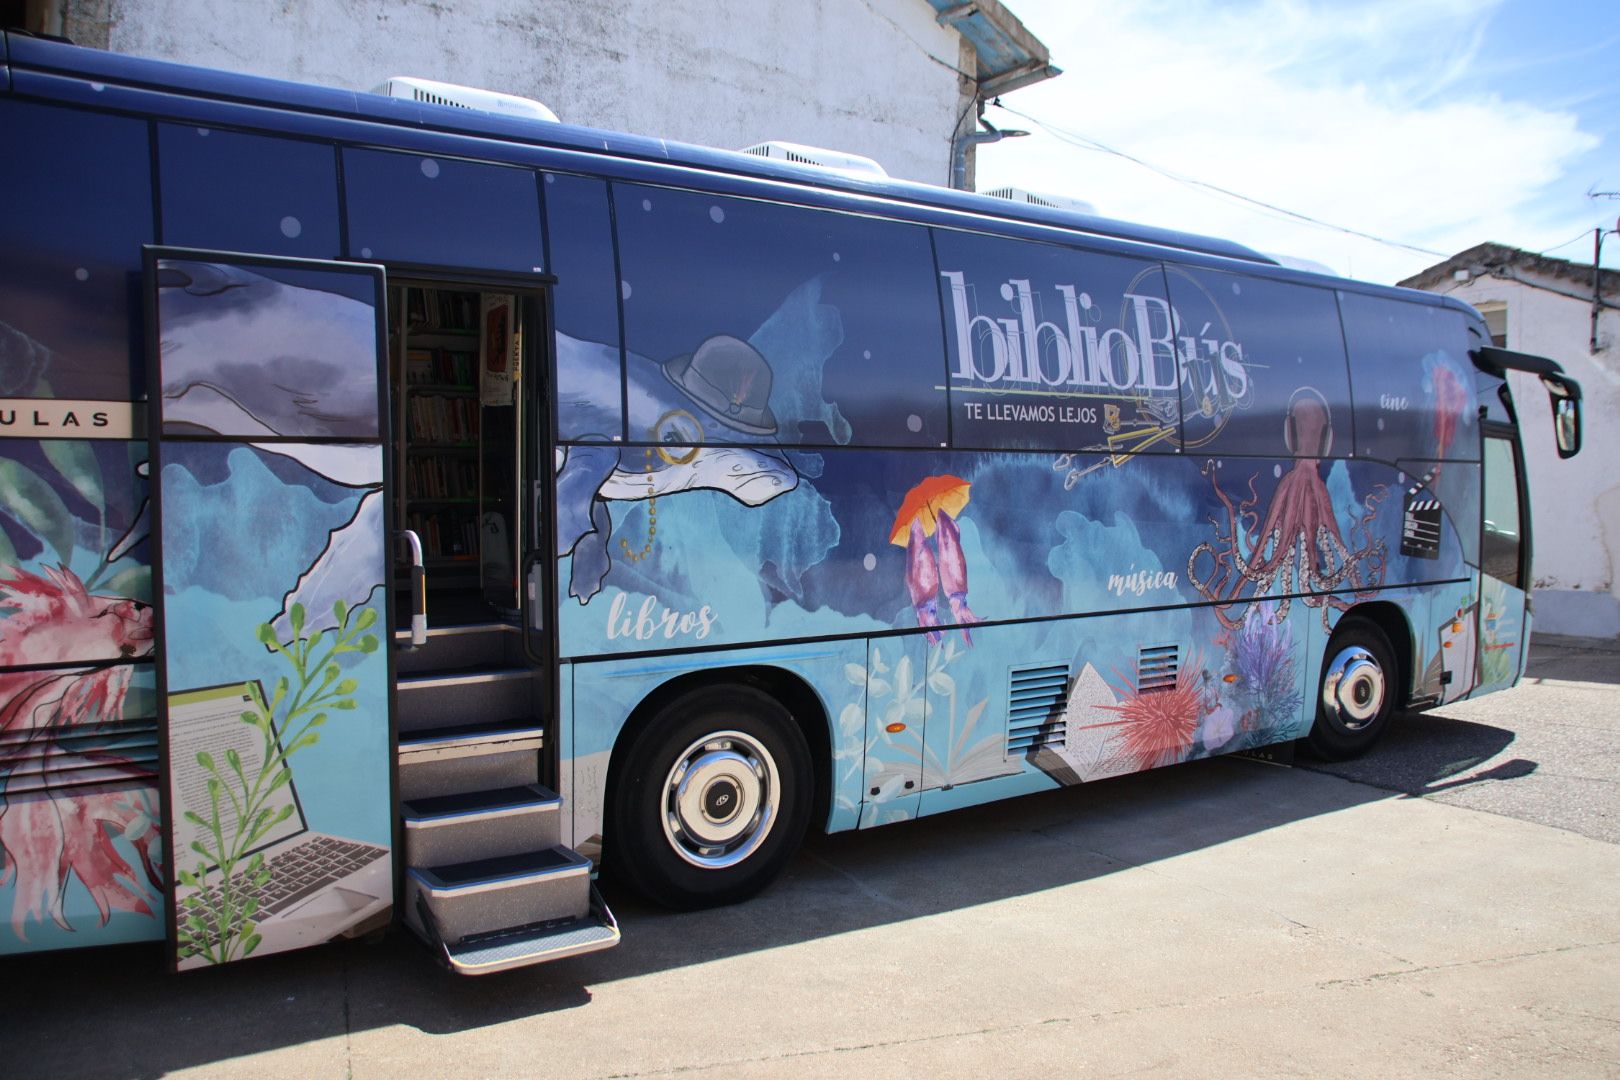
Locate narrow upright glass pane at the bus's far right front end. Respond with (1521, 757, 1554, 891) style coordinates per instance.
(1471, 427, 1529, 696)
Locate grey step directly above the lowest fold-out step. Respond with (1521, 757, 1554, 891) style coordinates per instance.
(405, 847, 591, 946)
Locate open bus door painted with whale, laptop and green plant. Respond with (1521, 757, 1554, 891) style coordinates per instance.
(144, 248, 395, 970)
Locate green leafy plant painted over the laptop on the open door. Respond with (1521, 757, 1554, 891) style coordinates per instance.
(177, 601, 381, 963)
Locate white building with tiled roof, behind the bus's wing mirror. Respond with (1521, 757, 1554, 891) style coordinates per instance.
(1400, 244, 1620, 638)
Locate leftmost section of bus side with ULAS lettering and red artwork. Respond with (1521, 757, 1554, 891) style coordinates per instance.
(0, 99, 164, 954)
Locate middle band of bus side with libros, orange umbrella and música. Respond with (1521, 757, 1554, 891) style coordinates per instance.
(559, 447, 1477, 657)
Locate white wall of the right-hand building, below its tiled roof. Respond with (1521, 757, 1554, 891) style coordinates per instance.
(1435, 269, 1620, 638)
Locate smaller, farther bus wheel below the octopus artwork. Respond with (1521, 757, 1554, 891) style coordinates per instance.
(1306, 615, 1400, 761)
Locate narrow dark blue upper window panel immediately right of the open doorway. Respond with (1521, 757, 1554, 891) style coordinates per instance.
(544, 173, 624, 442)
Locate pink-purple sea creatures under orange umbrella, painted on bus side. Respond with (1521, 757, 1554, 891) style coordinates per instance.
(889, 476, 980, 644)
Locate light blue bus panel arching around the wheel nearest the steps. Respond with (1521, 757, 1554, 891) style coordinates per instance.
(561, 638, 868, 858)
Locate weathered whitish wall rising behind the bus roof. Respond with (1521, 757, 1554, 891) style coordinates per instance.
(41, 0, 974, 185)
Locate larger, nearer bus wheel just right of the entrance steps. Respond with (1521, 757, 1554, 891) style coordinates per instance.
(604, 685, 812, 910)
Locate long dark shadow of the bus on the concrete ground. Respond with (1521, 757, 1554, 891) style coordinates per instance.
(0, 758, 1388, 1077)
